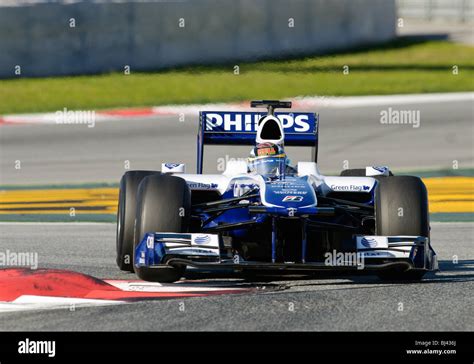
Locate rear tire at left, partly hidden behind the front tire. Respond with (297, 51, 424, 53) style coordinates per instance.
(116, 171, 159, 272)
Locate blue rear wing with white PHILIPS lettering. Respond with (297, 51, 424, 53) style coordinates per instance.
(197, 111, 319, 174)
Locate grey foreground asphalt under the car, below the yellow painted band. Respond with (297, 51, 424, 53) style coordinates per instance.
(0, 223, 474, 331)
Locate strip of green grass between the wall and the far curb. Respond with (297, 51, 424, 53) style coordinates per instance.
(0, 40, 474, 114)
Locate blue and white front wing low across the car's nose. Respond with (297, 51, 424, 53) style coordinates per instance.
(134, 232, 438, 271)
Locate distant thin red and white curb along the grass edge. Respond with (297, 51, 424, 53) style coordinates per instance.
(0, 92, 474, 125)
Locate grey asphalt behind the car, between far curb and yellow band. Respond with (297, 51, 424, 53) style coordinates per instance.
(0, 101, 474, 185)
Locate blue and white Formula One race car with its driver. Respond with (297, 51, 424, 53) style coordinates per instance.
(117, 101, 437, 282)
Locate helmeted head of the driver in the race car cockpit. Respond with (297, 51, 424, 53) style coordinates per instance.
(249, 143, 286, 177)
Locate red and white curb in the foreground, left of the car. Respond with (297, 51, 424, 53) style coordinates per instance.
(0, 268, 256, 313)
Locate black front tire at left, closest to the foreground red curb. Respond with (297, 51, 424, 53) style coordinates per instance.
(133, 175, 191, 283)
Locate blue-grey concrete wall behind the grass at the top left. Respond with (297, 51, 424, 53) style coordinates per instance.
(0, 0, 396, 78)
